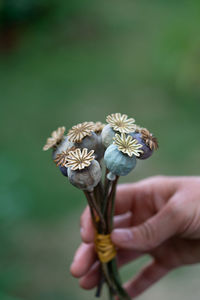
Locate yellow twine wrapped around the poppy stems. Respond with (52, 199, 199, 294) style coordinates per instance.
(95, 233, 116, 263)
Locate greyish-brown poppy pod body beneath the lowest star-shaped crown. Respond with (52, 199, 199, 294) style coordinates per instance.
(68, 160, 101, 191)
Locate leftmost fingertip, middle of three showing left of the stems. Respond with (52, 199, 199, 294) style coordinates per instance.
(70, 243, 97, 278)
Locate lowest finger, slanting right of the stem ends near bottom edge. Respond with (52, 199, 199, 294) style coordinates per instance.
(125, 261, 169, 299)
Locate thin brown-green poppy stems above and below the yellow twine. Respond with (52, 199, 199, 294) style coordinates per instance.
(84, 169, 131, 300)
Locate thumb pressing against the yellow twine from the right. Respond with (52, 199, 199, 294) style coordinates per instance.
(111, 205, 180, 251)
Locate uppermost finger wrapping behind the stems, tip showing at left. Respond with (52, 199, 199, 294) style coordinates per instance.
(81, 176, 176, 243)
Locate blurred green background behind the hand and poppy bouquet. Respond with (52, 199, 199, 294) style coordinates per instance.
(0, 0, 200, 300)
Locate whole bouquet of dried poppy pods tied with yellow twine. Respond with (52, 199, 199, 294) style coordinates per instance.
(43, 113, 158, 300)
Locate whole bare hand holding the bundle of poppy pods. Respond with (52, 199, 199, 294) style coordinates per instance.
(71, 176, 200, 299)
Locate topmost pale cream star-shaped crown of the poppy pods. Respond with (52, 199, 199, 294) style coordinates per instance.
(106, 113, 135, 133)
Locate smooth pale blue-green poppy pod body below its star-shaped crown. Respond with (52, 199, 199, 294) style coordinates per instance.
(104, 144, 136, 176)
